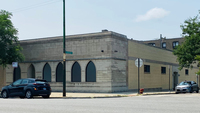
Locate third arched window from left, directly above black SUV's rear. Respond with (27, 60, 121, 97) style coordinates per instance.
(43, 63, 51, 82)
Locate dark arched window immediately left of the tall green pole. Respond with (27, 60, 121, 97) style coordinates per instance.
(56, 62, 63, 82)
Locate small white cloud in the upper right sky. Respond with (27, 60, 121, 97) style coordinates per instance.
(135, 7, 170, 22)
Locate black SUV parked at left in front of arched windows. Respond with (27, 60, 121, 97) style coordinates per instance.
(1, 78, 51, 98)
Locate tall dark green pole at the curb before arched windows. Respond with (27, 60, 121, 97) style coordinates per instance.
(63, 0, 66, 97)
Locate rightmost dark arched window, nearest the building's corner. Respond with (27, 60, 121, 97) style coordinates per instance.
(86, 61, 96, 82)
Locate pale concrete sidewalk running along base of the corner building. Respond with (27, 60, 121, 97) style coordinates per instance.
(50, 91, 175, 98)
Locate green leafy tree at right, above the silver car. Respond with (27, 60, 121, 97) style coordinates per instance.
(173, 11, 200, 70)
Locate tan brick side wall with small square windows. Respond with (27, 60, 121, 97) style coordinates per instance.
(128, 40, 198, 90)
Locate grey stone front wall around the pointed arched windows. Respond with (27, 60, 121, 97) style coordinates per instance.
(6, 31, 127, 92)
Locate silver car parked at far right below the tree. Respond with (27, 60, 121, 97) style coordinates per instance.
(175, 81, 199, 94)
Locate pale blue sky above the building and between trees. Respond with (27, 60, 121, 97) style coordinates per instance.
(0, 0, 200, 40)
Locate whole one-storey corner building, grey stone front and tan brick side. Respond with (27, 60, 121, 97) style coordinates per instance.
(2, 31, 198, 92)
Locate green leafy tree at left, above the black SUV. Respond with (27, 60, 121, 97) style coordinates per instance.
(0, 10, 24, 67)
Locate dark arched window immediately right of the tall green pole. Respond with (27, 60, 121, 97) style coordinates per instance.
(71, 62, 81, 82)
